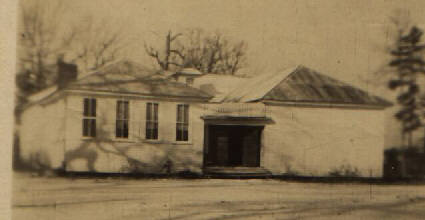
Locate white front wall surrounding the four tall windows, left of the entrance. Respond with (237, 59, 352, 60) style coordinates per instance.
(65, 95, 204, 173)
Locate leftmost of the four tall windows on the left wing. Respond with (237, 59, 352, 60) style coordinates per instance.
(83, 98, 96, 137)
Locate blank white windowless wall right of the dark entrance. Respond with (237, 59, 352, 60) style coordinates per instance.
(261, 106, 385, 177)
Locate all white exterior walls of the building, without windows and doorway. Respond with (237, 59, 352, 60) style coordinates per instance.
(20, 90, 385, 176)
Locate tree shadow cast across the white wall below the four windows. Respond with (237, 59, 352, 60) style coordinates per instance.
(64, 111, 202, 175)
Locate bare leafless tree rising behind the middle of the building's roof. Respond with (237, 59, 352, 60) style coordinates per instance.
(145, 28, 247, 75)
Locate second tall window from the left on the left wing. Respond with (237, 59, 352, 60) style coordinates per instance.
(115, 99, 130, 139)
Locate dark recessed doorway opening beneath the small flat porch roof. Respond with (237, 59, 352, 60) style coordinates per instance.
(205, 125, 263, 167)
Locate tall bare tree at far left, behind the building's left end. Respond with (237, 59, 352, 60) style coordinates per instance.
(17, 0, 75, 93)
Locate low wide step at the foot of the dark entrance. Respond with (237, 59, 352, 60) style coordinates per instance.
(204, 167, 272, 178)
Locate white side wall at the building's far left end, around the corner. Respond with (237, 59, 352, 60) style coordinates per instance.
(19, 99, 65, 169)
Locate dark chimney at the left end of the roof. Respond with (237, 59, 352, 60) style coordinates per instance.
(57, 55, 78, 89)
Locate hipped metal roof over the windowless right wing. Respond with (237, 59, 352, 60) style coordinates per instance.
(217, 65, 392, 107)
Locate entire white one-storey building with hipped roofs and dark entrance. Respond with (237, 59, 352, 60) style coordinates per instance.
(20, 61, 391, 177)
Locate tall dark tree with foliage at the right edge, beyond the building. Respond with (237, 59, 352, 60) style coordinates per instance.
(388, 26, 425, 146)
